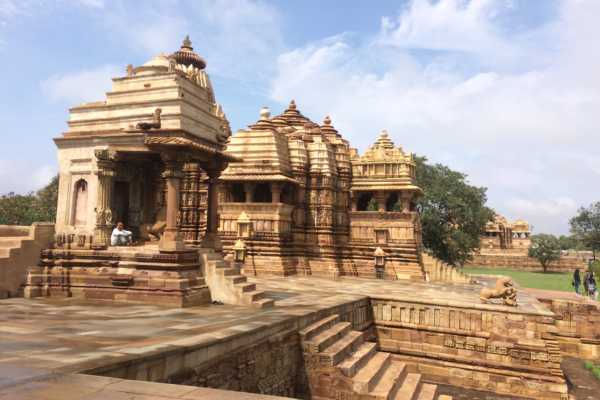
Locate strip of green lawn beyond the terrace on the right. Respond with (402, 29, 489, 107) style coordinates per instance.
(462, 268, 573, 292)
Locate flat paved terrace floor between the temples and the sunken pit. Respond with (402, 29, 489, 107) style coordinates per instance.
(0, 277, 552, 399)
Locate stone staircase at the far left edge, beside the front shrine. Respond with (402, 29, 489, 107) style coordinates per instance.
(0, 223, 54, 298)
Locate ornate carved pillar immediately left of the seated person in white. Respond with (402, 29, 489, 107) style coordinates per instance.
(92, 150, 115, 249)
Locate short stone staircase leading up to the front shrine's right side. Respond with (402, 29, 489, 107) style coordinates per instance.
(198, 248, 275, 308)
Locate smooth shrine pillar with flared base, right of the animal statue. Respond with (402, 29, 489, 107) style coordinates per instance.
(158, 157, 185, 252)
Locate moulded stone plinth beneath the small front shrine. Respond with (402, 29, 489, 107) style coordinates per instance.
(24, 245, 211, 307)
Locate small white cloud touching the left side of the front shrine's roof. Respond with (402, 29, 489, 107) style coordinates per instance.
(40, 65, 124, 106)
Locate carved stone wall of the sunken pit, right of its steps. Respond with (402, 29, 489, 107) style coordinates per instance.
(371, 299, 567, 399)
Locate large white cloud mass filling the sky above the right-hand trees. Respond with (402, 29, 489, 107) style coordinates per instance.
(271, 0, 600, 232)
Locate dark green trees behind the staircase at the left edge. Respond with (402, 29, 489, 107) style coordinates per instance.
(0, 176, 58, 225)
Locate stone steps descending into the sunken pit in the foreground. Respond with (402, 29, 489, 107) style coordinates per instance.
(300, 315, 452, 400)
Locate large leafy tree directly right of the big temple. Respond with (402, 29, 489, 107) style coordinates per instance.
(415, 157, 494, 266)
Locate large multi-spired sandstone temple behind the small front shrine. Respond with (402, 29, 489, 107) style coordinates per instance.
(213, 101, 423, 279)
